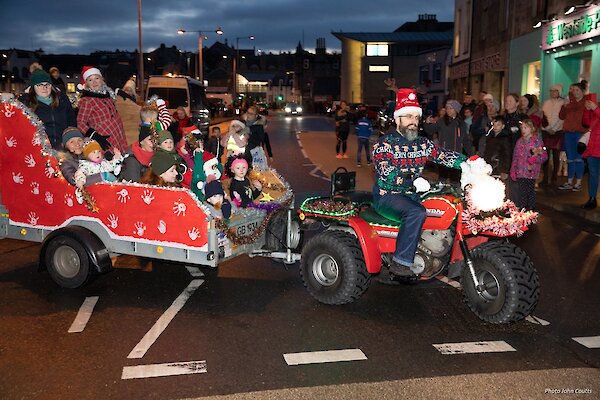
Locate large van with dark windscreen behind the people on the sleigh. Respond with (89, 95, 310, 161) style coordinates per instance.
(146, 75, 210, 133)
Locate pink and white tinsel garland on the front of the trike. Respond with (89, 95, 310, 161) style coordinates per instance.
(462, 200, 538, 236)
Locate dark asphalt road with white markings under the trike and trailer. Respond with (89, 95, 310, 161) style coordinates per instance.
(0, 115, 600, 399)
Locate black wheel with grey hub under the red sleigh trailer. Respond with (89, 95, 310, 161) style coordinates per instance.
(44, 235, 95, 289)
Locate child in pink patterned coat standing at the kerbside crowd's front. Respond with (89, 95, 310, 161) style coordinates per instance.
(510, 119, 548, 210)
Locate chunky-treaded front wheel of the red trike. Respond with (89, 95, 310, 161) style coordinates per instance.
(461, 242, 540, 324)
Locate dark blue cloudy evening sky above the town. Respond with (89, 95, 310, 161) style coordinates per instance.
(0, 0, 454, 54)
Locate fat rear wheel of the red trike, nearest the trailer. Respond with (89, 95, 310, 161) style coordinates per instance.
(300, 230, 371, 304)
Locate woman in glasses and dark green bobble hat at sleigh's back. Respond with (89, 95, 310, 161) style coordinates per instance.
(19, 69, 77, 150)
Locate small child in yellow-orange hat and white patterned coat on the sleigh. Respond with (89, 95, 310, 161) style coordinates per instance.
(75, 140, 123, 188)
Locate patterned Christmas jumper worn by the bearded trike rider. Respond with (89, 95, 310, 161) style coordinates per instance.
(373, 131, 467, 195)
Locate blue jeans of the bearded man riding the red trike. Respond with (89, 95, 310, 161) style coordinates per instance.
(373, 190, 427, 267)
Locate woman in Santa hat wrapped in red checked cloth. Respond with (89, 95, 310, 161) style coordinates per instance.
(77, 66, 127, 158)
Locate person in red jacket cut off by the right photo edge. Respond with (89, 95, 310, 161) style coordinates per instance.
(581, 100, 600, 210)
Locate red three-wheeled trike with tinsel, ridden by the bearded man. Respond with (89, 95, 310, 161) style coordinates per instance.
(298, 167, 539, 324)
